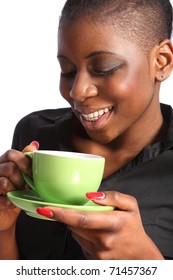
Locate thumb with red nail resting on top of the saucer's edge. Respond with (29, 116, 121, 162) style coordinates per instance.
(86, 191, 138, 211)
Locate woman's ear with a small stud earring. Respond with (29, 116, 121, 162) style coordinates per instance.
(156, 39, 173, 82)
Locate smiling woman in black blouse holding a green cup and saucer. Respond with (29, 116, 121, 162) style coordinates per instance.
(0, 0, 173, 259)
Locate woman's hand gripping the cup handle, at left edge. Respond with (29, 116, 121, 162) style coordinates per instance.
(0, 141, 39, 233)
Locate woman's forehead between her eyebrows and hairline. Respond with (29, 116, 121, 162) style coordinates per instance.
(58, 18, 141, 59)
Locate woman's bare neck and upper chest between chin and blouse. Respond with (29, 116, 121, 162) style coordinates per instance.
(73, 104, 166, 178)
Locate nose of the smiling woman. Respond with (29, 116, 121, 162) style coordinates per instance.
(70, 74, 98, 102)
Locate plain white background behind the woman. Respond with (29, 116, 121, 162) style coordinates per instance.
(0, 0, 173, 155)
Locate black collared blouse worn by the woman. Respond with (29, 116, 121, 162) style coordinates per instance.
(12, 104, 173, 260)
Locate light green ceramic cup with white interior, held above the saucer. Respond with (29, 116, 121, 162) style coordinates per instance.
(23, 150, 105, 205)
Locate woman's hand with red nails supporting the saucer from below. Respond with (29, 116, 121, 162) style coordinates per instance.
(38, 191, 163, 260)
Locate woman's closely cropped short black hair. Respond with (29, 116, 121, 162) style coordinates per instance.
(59, 0, 173, 50)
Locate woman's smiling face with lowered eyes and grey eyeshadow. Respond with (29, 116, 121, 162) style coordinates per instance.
(58, 19, 155, 144)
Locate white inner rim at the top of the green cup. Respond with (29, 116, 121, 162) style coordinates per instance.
(33, 150, 105, 160)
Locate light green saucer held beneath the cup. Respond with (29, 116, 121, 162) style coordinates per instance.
(7, 190, 114, 220)
